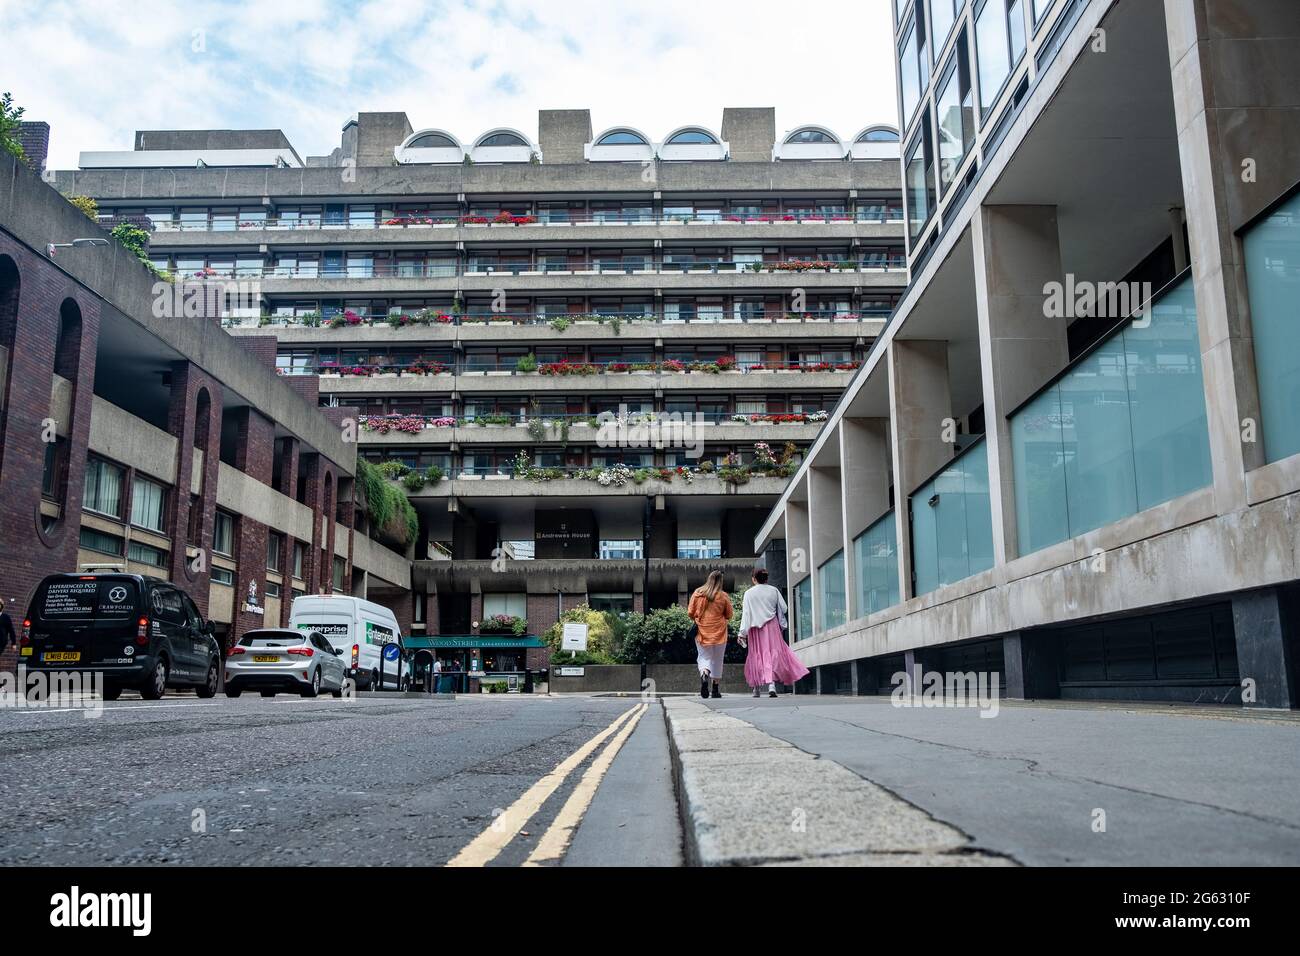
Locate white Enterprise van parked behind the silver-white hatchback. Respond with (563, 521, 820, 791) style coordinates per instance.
(289, 594, 411, 691)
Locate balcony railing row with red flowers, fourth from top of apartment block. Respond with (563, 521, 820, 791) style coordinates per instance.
(300, 359, 862, 378)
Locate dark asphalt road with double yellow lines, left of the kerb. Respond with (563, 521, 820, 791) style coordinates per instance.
(0, 695, 681, 866)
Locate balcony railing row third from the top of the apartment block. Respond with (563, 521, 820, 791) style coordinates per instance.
(221, 308, 889, 332)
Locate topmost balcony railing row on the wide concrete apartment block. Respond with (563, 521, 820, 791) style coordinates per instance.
(119, 206, 904, 233)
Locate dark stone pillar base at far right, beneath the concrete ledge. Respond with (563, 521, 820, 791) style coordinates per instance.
(1232, 588, 1300, 708)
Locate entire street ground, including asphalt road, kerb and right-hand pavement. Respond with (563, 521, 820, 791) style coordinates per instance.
(0, 695, 1300, 866)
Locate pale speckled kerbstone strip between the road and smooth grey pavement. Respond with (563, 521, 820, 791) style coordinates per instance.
(663, 698, 1009, 866)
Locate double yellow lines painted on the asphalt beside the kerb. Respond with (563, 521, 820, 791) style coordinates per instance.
(447, 704, 649, 866)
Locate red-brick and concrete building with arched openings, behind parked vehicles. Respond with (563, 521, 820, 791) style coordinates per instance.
(0, 153, 411, 669)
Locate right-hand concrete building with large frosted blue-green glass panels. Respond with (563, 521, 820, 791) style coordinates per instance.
(757, 0, 1300, 708)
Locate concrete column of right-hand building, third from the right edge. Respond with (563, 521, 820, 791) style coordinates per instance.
(888, 338, 953, 601)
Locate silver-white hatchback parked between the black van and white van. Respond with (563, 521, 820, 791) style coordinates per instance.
(226, 627, 347, 697)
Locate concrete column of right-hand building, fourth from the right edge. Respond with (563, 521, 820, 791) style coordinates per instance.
(840, 419, 891, 620)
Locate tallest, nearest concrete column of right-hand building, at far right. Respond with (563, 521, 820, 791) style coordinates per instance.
(1165, 0, 1284, 514)
